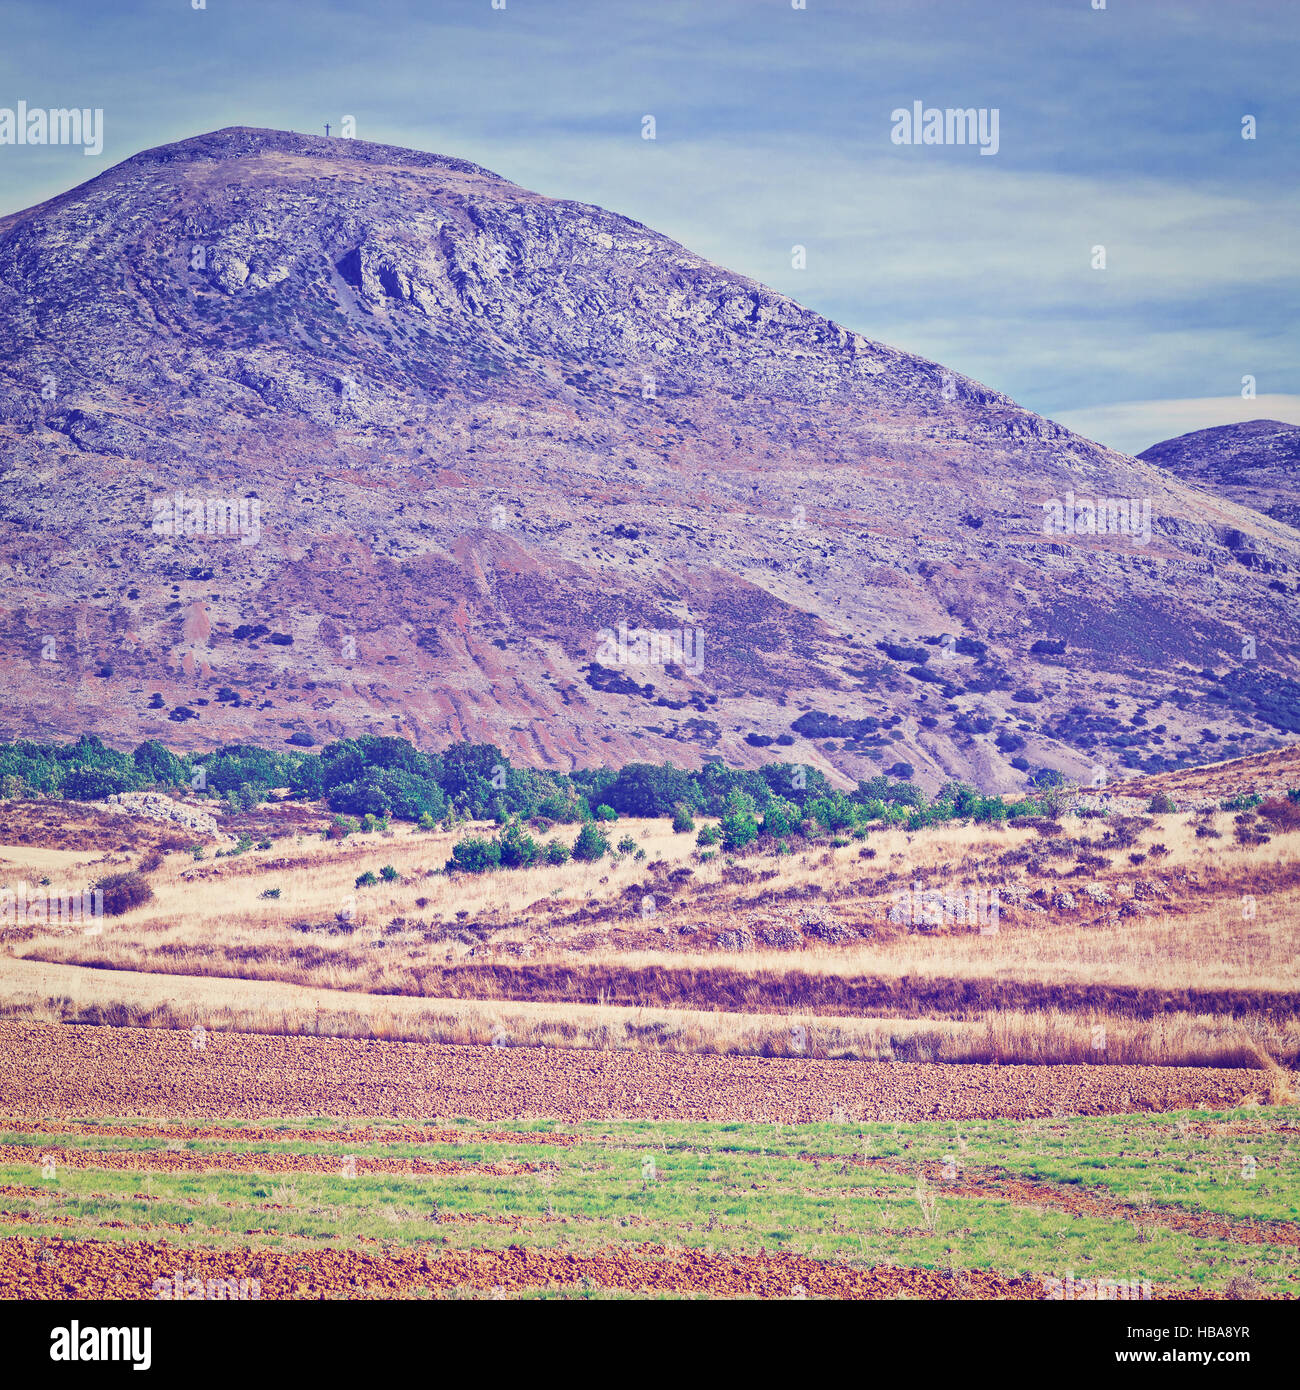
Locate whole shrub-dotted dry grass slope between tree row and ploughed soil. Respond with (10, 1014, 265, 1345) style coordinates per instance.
(0, 774, 1300, 1066)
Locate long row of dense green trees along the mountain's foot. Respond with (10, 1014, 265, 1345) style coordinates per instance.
(0, 734, 1056, 834)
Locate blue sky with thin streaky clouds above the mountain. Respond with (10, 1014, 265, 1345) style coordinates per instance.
(0, 0, 1300, 453)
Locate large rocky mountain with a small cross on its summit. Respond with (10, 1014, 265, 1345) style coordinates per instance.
(0, 129, 1300, 791)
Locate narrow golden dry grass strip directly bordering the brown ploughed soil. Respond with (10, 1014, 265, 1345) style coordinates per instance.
(0, 960, 1300, 1061)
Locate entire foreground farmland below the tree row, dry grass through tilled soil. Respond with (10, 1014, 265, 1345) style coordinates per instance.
(0, 755, 1300, 1298)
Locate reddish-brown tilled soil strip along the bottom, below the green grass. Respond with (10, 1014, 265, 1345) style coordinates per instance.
(0, 1236, 1205, 1300)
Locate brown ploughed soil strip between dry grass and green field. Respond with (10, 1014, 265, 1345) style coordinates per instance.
(0, 1023, 1265, 1123)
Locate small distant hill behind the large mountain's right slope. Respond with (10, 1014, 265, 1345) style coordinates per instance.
(1137, 420, 1300, 528)
